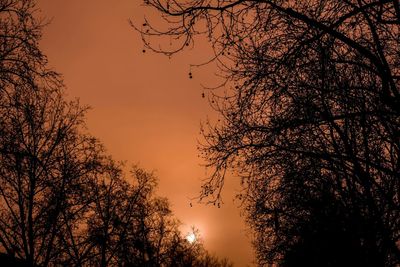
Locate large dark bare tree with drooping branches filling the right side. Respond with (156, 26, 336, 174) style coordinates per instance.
(139, 0, 400, 266)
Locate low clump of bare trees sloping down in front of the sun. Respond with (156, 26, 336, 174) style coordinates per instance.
(58, 162, 232, 267)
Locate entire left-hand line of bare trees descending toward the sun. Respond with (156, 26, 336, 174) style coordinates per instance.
(0, 0, 236, 267)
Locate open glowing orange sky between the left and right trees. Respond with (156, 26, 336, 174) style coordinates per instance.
(38, 0, 252, 266)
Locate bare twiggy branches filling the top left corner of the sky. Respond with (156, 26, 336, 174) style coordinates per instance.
(0, 0, 58, 95)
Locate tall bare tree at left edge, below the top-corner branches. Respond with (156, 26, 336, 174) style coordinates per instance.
(0, 77, 106, 266)
